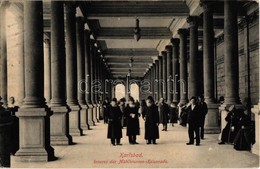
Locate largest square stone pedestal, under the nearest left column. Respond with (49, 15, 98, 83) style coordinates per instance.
(14, 108, 55, 162)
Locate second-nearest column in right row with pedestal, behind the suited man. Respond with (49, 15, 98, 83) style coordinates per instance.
(201, 2, 220, 133)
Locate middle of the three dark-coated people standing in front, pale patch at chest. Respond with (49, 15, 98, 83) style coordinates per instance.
(124, 96, 140, 144)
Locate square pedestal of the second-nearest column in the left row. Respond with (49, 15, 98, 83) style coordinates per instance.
(51, 106, 72, 145)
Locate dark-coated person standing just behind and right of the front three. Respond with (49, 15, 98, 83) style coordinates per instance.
(158, 98, 170, 131)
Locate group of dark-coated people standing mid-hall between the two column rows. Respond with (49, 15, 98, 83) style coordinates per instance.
(103, 96, 208, 146)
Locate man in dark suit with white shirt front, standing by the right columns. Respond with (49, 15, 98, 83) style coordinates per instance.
(187, 97, 200, 146)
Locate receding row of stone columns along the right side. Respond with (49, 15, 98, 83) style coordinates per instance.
(144, 1, 240, 133)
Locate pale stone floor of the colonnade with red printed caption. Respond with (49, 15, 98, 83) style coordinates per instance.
(11, 120, 259, 168)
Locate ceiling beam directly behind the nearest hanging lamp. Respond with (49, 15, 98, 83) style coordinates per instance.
(95, 27, 172, 40)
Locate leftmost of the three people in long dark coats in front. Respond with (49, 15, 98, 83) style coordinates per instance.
(107, 98, 122, 146)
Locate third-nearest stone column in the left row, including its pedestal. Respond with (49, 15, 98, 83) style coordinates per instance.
(65, 2, 83, 136)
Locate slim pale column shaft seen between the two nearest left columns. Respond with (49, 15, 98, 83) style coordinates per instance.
(44, 37, 51, 105)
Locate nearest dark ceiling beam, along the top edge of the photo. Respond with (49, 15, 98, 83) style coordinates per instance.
(80, 0, 189, 19)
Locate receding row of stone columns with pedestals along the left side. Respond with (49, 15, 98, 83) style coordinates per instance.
(0, 1, 111, 161)
